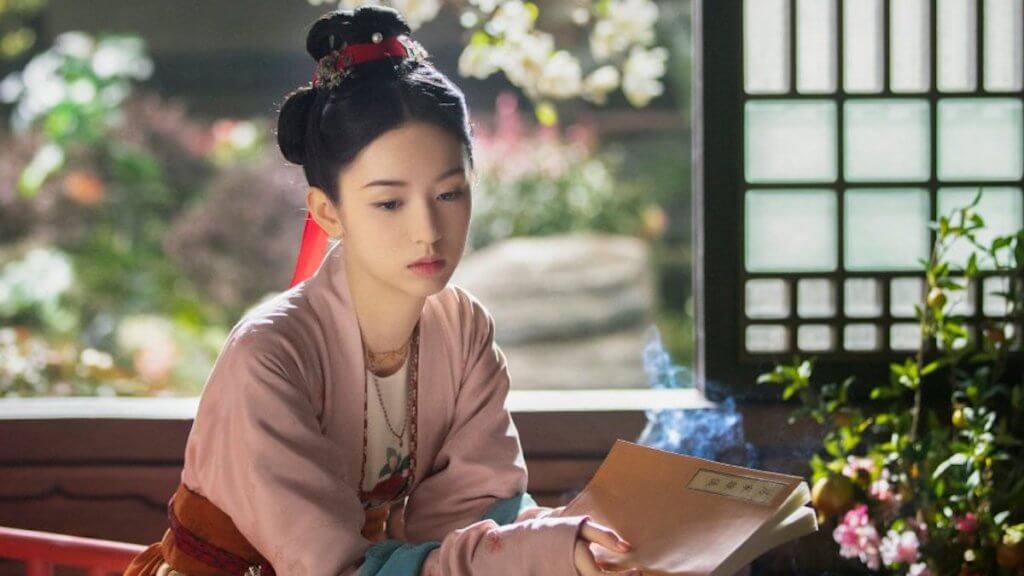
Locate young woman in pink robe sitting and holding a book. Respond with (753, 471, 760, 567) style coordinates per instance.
(121, 7, 629, 576)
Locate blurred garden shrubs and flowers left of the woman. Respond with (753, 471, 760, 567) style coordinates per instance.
(0, 33, 301, 396)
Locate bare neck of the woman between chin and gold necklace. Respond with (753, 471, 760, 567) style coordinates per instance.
(345, 255, 425, 354)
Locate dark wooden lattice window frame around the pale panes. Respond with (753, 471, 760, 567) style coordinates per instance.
(692, 0, 1024, 402)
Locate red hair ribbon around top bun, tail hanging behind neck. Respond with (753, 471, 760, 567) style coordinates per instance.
(289, 36, 410, 287)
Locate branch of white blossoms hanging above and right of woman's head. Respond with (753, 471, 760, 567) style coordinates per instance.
(307, 0, 669, 124)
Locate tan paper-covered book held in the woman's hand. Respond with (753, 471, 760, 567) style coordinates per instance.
(563, 440, 818, 576)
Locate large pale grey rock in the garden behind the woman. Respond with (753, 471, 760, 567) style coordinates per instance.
(452, 234, 655, 388)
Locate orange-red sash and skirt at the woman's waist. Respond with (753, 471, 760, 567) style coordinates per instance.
(124, 484, 390, 576)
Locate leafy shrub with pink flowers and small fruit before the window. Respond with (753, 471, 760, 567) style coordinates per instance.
(760, 191, 1024, 576)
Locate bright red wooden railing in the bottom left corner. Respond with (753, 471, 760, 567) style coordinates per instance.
(0, 527, 145, 576)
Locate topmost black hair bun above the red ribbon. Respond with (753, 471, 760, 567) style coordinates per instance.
(306, 5, 411, 60)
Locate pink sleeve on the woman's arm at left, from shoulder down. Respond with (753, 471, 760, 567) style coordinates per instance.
(183, 333, 370, 576)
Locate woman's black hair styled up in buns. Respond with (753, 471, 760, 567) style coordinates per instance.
(278, 6, 472, 203)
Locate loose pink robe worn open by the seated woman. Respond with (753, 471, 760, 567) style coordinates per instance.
(182, 239, 583, 576)
